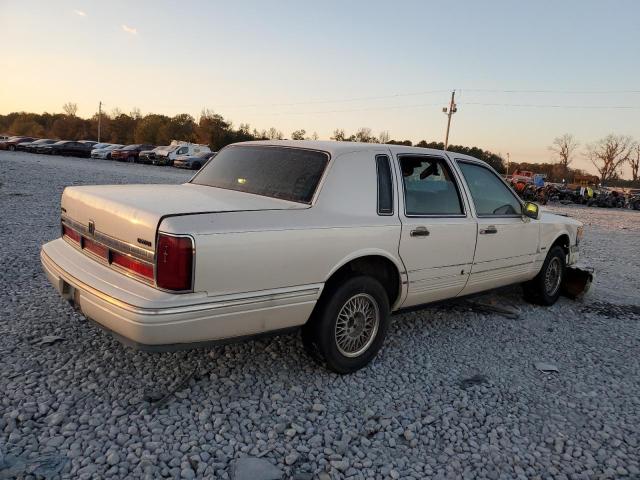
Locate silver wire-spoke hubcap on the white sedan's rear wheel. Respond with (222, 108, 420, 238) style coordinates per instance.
(335, 293, 380, 357)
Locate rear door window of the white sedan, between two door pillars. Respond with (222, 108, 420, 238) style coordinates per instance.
(399, 155, 464, 216)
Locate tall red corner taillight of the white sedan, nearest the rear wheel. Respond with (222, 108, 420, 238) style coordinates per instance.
(156, 233, 193, 290)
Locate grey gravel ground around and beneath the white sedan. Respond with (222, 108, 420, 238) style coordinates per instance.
(0, 152, 640, 480)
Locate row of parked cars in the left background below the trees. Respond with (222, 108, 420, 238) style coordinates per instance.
(0, 136, 215, 170)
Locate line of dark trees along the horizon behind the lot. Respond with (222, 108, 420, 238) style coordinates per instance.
(0, 106, 640, 186)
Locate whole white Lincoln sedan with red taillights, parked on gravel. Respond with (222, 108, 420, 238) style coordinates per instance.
(41, 141, 582, 373)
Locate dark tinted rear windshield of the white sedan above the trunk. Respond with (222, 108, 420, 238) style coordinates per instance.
(191, 142, 329, 203)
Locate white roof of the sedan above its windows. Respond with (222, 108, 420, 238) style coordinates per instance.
(233, 140, 486, 164)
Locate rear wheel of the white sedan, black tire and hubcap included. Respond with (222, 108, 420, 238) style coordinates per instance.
(302, 276, 389, 374)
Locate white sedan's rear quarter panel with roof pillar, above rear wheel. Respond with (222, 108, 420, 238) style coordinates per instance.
(160, 150, 404, 296)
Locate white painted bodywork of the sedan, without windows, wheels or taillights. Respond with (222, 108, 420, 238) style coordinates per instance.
(41, 141, 580, 346)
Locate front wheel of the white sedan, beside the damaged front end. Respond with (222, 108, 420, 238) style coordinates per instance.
(523, 245, 566, 306)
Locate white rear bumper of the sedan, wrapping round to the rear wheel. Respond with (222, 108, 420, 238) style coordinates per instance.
(40, 239, 322, 350)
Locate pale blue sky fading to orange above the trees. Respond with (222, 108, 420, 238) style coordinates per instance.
(0, 0, 640, 176)
